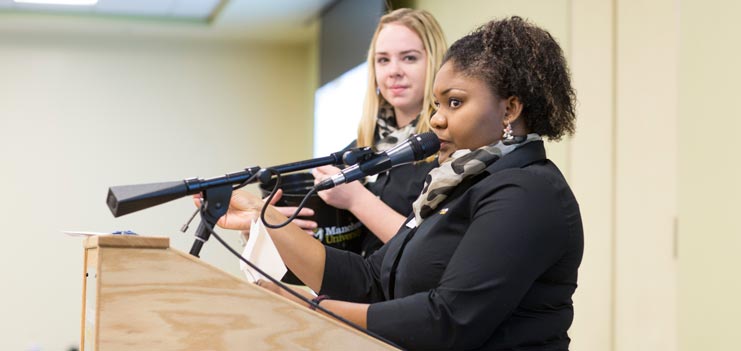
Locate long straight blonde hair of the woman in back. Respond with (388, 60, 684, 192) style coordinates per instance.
(358, 8, 448, 147)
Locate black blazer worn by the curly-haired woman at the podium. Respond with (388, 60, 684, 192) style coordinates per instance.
(320, 142, 583, 350)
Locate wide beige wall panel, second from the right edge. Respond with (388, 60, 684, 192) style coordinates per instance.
(614, 0, 679, 351)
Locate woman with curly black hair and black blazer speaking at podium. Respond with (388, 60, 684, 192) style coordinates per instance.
(211, 17, 583, 350)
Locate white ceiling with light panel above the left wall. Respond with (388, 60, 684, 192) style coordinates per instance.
(0, 0, 337, 42)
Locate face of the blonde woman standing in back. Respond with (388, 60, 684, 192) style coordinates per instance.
(374, 23, 427, 115)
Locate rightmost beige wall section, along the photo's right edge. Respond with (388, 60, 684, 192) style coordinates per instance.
(679, 0, 741, 351)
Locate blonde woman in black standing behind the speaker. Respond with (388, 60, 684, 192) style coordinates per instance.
(310, 9, 447, 256)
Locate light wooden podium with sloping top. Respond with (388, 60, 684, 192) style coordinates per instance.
(80, 235, 395, 351)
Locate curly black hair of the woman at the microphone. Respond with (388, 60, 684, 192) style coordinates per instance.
(443, 16, 576, 140)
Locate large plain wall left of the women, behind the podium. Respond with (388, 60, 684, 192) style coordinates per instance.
(0, 24, 316, 350)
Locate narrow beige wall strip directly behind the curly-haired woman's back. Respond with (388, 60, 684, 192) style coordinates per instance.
(569, 0, 616, 351)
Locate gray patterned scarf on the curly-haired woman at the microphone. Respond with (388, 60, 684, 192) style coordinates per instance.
(412, 133, 542, 225)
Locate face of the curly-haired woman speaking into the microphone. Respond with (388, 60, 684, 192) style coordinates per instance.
(430, 61, 507, 163)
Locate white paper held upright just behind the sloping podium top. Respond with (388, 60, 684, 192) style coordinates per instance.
(239, 221, 288, 282)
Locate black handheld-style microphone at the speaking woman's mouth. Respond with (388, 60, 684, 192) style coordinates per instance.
(314, 132, 440, 191)
